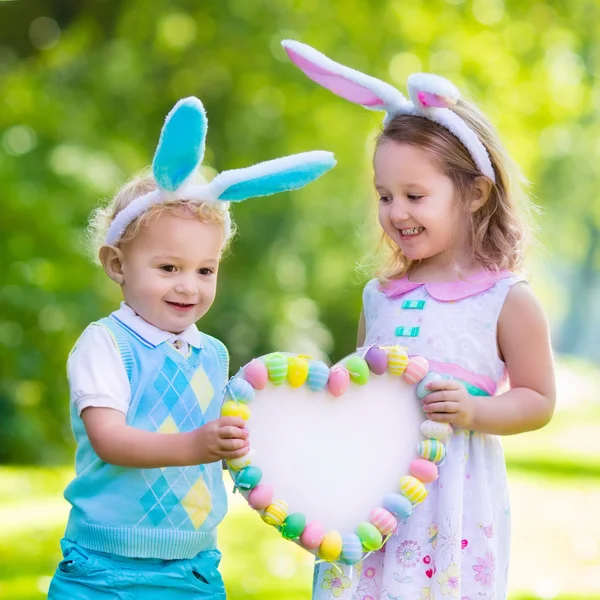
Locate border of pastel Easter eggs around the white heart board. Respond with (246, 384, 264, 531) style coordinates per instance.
(222, 345, 452, 565)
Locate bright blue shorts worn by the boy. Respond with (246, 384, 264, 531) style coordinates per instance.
(48, 539, 225, 600)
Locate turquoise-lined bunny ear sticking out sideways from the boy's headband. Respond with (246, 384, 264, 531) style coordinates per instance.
(208, 150, 336, 202)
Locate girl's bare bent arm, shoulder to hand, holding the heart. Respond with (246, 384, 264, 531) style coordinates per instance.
(423, 284, 556, 435)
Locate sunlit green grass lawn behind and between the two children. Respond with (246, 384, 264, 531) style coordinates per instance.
(0, 358, 600, 600)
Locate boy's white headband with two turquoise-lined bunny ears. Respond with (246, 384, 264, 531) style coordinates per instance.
(105, 96, 336, 245)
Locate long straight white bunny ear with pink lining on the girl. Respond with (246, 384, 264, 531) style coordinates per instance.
(281, 40, 408, 112)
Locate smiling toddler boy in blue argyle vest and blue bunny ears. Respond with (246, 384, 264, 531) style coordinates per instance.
(49, 98, 335, 600)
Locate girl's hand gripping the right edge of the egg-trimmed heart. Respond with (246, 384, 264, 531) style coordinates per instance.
(421, 379, 475, 429)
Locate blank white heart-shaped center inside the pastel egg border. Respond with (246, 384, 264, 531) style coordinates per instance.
(247, 374, 424, 532)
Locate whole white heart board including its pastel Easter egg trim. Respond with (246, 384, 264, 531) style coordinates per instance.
(221, 346, 451, 564)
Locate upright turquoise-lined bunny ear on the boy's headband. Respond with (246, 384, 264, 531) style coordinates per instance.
(152, 96, 208, 192)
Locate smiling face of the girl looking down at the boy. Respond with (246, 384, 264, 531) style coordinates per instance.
(373, 140, 468, 264)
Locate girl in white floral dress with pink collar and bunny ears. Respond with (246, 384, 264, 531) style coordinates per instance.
(283, 42, 555, 600)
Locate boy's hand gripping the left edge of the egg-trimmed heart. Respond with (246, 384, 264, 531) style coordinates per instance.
(192, 417, 250, 464)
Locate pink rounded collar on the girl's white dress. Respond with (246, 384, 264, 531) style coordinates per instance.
(379, 270, 514, 302)
